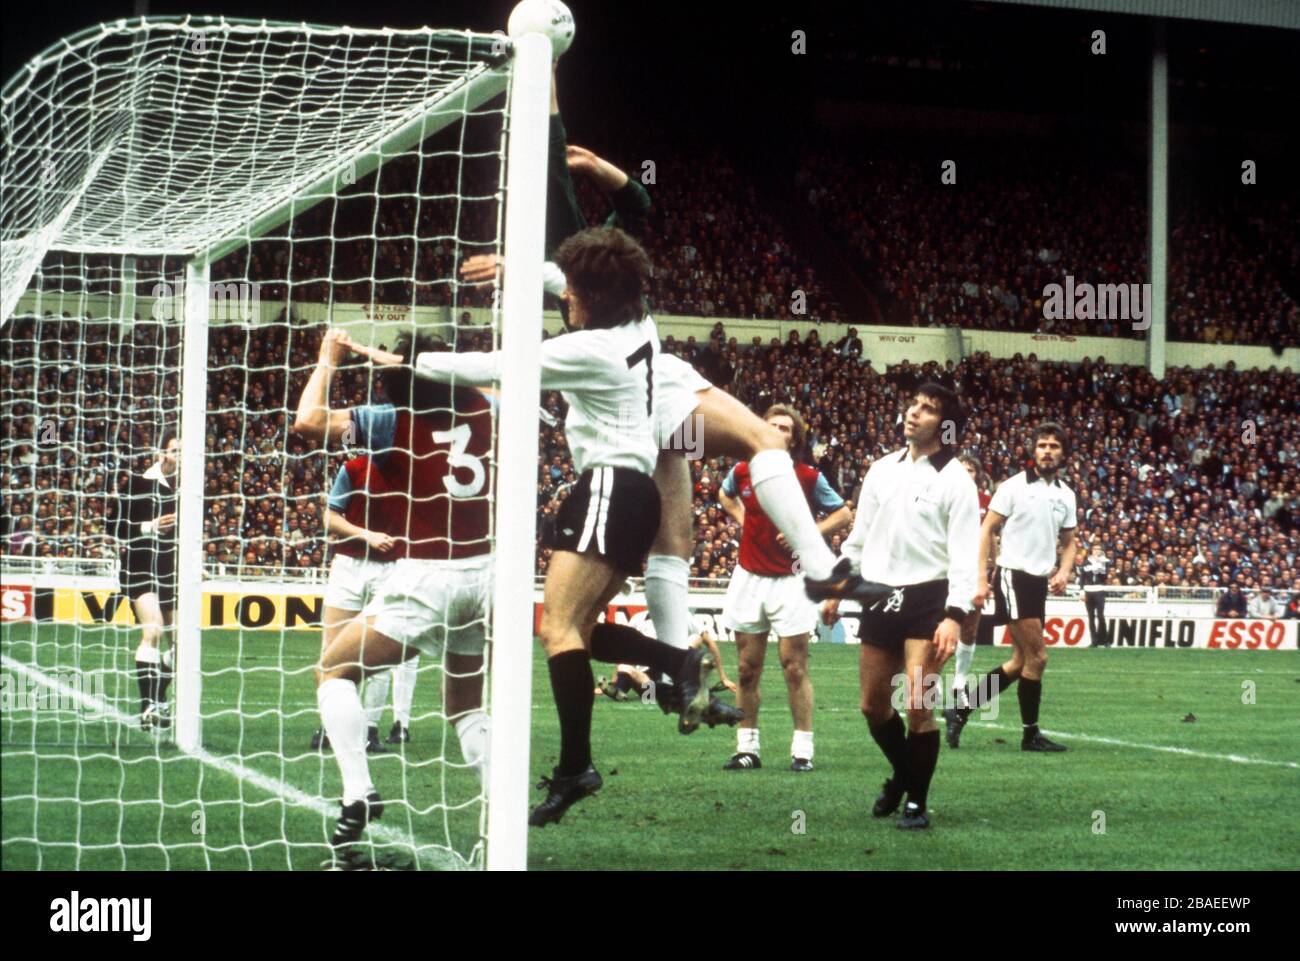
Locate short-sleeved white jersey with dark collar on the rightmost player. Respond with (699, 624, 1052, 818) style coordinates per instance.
(988, 467, 1078, 577)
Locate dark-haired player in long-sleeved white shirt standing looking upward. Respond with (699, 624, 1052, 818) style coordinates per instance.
(822, 384, 980, 831)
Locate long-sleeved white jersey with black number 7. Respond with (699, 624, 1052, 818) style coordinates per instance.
(415, 315, 659, 475)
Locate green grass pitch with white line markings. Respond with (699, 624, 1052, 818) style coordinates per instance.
(0, 624, 1300, 870)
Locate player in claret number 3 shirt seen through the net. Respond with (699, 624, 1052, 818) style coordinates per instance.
(294, 330, 493, 865)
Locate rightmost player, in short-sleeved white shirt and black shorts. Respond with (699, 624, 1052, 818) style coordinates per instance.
(971, 421, 1078, 752)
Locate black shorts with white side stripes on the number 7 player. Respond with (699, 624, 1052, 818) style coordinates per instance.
(555, 467, 659, 575)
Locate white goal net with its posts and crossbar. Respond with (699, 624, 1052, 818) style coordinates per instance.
(0, 17, 550, 870)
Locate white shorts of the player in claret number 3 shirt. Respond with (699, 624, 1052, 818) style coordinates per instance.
(364, 554, 491, 659)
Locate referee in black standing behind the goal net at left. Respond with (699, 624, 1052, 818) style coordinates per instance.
(113, 428, 181, 730)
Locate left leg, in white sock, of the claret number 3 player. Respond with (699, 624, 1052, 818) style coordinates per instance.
(316, 618, 415, 863)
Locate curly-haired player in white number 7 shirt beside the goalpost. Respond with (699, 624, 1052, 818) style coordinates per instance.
(358, 228, 714, 827)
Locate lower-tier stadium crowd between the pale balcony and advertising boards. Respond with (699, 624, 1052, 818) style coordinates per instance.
(0, 306, 1300, 608)
